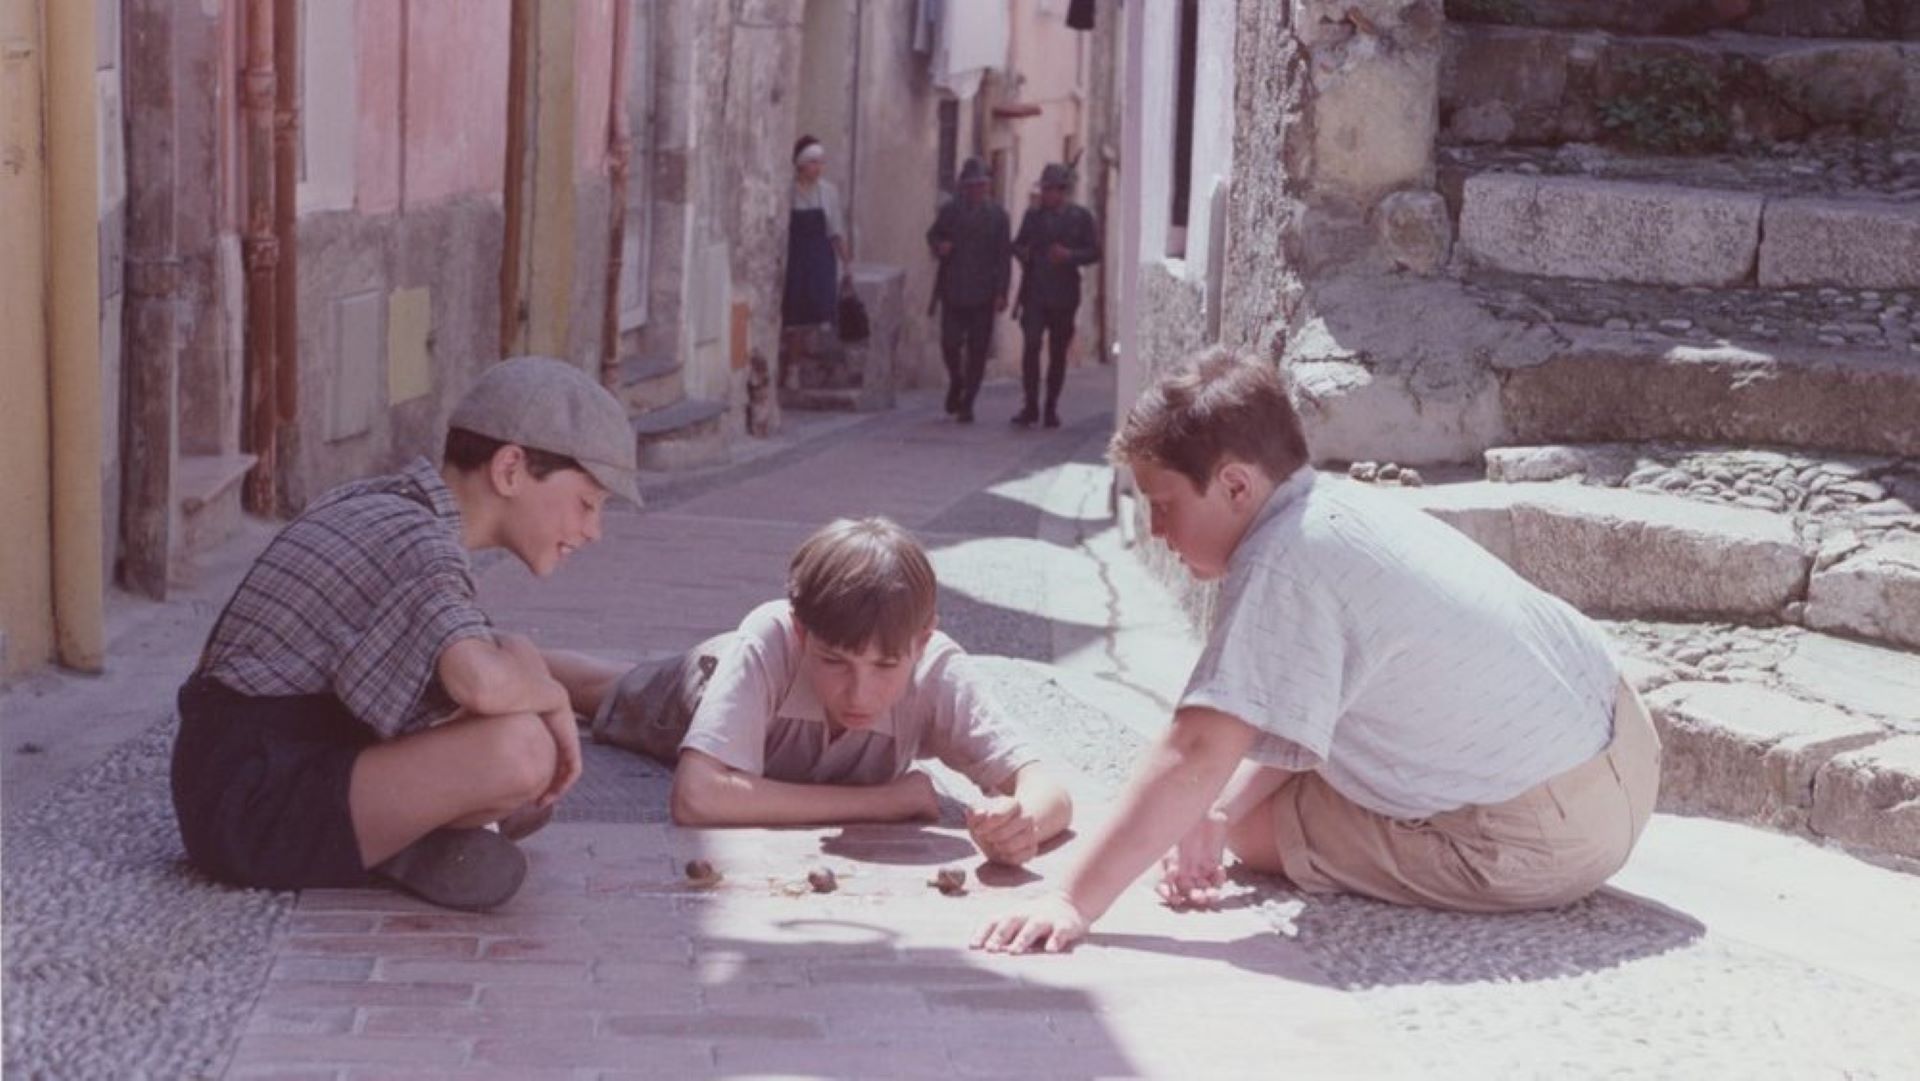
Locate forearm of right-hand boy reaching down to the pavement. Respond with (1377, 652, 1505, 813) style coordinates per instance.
(1066, 710, 1254, 920)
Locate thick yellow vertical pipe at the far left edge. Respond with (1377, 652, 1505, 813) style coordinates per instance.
(44, 0, 106, 672)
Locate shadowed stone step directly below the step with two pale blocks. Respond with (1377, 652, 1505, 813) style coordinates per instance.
(1496, 326, 1920, 457)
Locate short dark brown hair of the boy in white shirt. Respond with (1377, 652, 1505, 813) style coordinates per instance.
(1108, 346, 1309, 492)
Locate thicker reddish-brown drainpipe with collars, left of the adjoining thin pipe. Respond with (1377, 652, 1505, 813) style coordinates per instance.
(240, 0, 280, 515)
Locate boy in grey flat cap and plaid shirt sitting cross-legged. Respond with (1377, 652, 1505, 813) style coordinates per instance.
(173, 357, 639, 908)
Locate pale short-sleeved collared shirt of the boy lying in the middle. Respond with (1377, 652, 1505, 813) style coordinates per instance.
(680, 601, 1037, 793)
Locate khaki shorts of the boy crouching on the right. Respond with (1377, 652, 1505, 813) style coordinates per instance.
(1269, 682, 1661, 912)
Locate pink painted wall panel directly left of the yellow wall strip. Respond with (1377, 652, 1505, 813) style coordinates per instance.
(401, 0, 513, 207)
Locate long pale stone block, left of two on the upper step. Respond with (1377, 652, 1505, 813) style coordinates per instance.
(1459, 173, 1764, 286)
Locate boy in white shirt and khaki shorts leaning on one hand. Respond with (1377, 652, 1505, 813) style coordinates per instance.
(973, 351, 1661, 952)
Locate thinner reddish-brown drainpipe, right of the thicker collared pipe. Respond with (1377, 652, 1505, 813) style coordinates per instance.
(269, 0, 300, 476)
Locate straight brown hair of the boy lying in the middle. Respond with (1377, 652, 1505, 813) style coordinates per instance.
(787, 518, 937, 657)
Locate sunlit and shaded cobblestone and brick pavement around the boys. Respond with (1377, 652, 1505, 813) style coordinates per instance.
(0, 371, 1920, 1081)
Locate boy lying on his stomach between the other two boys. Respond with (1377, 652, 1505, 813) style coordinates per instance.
(564, 518, 1071, 866)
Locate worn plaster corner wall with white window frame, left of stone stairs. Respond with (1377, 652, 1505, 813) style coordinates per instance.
(1123, 0, 1497, 463)
